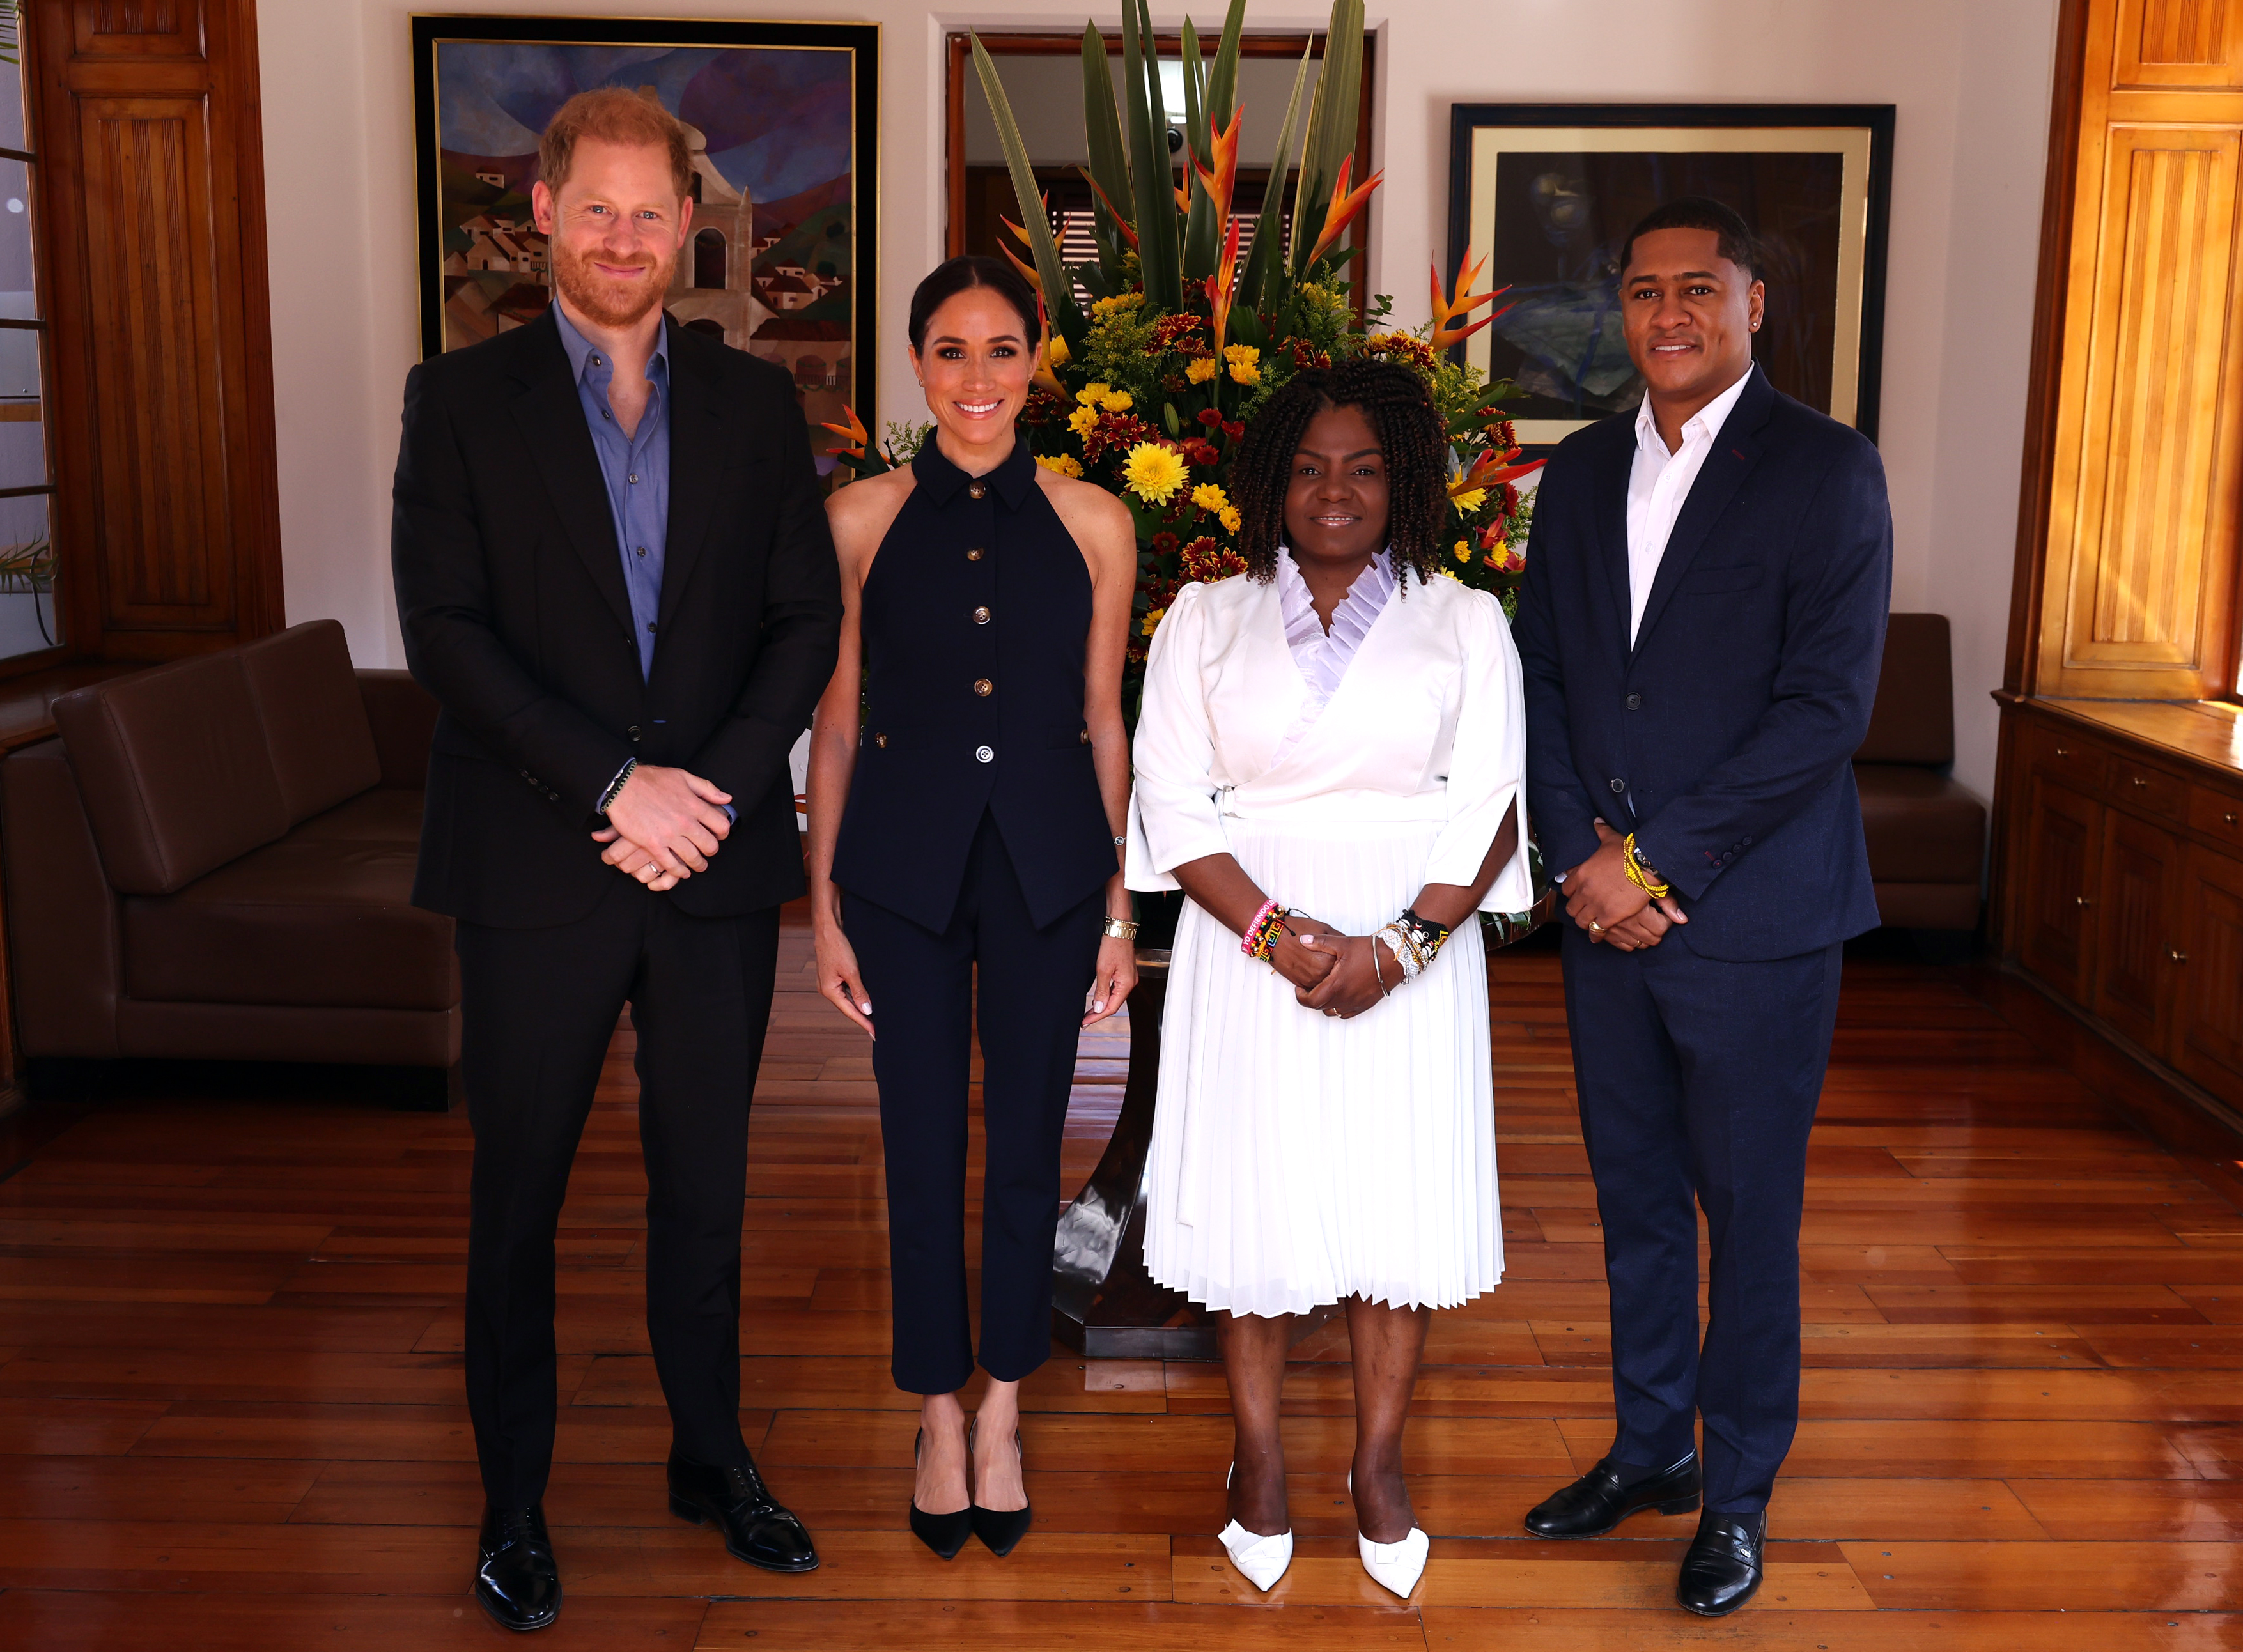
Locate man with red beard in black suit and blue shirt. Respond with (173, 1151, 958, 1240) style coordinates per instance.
(392, 88, 841, 1630)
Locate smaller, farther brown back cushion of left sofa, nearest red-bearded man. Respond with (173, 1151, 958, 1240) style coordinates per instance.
(240, 619, 382, 825)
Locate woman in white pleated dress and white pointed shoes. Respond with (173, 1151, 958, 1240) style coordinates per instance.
(1128, 361, 1532, 1596)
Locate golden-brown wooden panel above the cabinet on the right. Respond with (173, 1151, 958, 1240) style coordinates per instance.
(2010, 0, 2243, 699)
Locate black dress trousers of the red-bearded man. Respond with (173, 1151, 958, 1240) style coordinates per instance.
(458, 874, 779, 1509)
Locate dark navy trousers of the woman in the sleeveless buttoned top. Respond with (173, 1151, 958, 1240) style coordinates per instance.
(843, 816, 1106, 1394)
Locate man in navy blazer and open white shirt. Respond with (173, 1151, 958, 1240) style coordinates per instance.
(1514, 199, 1893, 1616)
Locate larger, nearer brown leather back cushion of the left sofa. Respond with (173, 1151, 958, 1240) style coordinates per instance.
(54, 650, 290, 894)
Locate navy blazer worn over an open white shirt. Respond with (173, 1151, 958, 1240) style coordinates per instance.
(1514, 367, 1893, 959)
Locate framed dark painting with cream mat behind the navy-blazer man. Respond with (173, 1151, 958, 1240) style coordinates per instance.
(1449, 103, 1893, 448)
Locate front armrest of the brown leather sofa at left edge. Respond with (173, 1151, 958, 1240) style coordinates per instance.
(0, 739, 123, 1060)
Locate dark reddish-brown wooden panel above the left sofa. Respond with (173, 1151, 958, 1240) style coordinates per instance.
(25, 0, 283, 659)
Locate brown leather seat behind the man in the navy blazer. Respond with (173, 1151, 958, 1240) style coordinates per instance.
(1852, 614, 1985, 930)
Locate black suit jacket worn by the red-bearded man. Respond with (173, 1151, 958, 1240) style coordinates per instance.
(391, 314, 841, 928)
